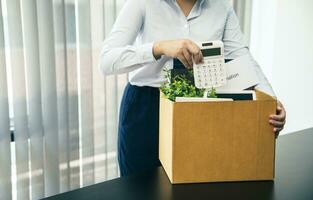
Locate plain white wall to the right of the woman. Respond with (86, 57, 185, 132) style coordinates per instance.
(250, 0, 313, 133)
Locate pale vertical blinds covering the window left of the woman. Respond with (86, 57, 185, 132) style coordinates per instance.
(0, 0, 248, 200)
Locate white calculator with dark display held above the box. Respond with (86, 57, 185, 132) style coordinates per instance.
(193, 41, 226, 89)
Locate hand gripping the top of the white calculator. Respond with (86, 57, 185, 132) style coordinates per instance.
(153, 39, 203, 69)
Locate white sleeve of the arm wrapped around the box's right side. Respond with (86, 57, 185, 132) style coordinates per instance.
(223, 7, 275, 96)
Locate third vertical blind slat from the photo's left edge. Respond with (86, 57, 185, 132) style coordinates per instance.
(21, 0, 44, 199)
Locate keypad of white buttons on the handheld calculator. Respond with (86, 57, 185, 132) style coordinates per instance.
(193, 58, 226, 89)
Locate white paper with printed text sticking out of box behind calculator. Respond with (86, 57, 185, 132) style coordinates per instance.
(217, 54, 259, 91)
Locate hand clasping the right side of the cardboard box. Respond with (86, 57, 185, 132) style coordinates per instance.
(269, 101, 286, 138)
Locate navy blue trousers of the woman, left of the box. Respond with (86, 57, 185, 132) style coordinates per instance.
(118, 84, 161, 176)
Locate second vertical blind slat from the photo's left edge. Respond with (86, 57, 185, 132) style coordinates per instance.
(6, 0, 30, 200)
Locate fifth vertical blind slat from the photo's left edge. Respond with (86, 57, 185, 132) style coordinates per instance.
(53, 0, 70, 192)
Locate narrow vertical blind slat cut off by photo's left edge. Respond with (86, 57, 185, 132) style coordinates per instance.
(0, 1, 12, 200)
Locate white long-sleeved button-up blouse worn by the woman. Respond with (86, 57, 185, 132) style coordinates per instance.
(100, 0, 274, 96)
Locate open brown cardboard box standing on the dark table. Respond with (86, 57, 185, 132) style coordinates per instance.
(159, 91, 276, 184)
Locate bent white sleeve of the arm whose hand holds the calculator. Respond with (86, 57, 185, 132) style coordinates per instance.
(100, 0, 155, 75)
